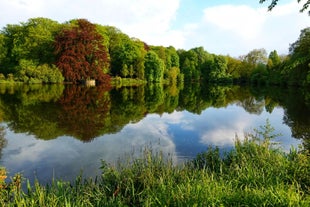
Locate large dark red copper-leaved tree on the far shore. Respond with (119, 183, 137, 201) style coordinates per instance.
(55, 19, 110, 84)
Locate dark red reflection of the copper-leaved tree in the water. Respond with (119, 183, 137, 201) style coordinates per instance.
(57, 85, 111, 142)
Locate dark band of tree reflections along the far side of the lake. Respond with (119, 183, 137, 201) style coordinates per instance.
(0, 83, 310, 148)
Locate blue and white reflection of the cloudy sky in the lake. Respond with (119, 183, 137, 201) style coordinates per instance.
(1, 105, 300, 185)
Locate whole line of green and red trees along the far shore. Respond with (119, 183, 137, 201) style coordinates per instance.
(0, 17, 310, 87)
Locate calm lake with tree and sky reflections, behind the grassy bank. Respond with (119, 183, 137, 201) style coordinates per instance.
(0, 83, 310, 183)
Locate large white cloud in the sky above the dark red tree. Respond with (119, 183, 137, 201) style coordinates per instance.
(0, 0, 184, 47)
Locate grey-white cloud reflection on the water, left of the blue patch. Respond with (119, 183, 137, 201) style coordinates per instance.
(1, 115, 178, 180)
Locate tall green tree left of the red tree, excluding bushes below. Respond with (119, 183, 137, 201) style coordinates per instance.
(2, 18, 61, 66)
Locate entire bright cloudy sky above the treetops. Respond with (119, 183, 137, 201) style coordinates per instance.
(0, 0, 310, 57)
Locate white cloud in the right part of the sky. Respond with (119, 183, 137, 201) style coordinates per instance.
(184, 1, 309, 56)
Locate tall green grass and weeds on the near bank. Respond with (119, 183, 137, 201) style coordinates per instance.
(0, 122, 310, 206)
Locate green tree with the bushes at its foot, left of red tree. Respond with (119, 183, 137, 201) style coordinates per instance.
(0, 18, 63, 83)
